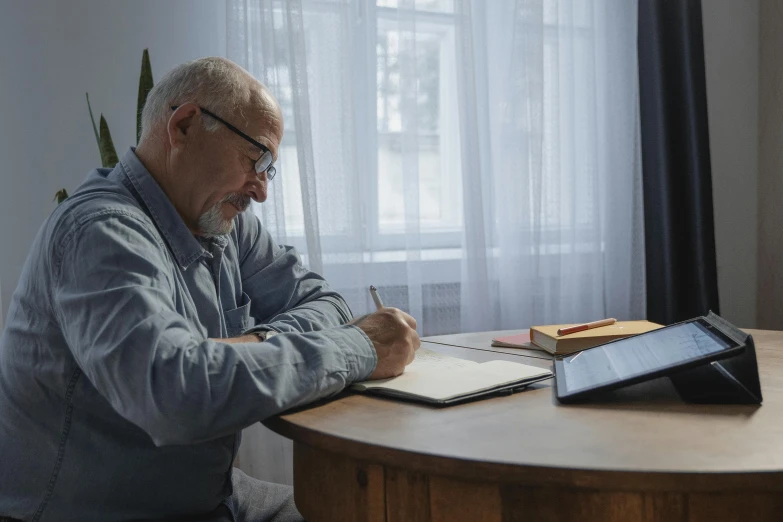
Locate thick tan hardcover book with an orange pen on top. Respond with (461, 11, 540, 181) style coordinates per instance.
(530, 321, 662, 355)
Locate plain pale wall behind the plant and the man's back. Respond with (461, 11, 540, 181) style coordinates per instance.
(0, 0, 226, 320)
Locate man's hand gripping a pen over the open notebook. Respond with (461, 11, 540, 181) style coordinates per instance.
(353, 308, 421, 380)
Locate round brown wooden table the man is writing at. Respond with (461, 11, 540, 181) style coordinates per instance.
(266, 330, 783, 522)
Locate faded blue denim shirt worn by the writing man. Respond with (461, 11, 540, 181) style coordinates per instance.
(0, 149, 377, 522)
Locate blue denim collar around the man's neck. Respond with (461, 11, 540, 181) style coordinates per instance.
(115, 147, 213, 269)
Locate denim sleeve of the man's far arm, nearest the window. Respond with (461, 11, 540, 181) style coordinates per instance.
(237, 214, 352, 333)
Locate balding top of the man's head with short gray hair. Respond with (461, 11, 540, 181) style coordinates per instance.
(141, 57, 251, 140)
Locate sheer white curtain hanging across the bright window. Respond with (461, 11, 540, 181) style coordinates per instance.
(227, 0, 645, 481)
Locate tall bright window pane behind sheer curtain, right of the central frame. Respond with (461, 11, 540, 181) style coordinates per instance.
(376, 19, 462, 233)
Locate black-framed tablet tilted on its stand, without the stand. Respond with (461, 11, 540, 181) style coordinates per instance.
(554, 317, 745, 402)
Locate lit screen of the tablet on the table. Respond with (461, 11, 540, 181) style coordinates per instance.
(558, 319, 741, 394)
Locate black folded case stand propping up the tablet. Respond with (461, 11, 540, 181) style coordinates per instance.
(669, 312, 762, 404)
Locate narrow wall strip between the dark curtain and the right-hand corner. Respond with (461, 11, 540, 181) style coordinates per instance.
(702, 0, 759, 328)
